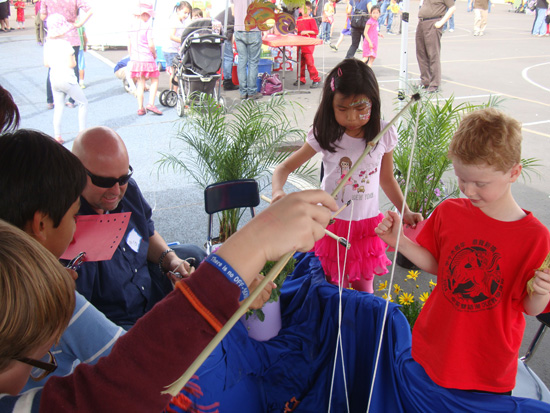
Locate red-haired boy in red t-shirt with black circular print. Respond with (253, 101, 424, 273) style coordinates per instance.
(376, 108, 550, 394)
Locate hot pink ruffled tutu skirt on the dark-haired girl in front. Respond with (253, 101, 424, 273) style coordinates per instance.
(315, 214, 391, 284)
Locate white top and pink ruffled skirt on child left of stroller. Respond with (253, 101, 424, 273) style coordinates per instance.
(128, 18, 159, 78)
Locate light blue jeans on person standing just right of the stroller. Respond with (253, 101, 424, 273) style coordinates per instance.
(234, 31, 262, 96)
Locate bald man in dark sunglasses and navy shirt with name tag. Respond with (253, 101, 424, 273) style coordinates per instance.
(72, 127, 206, 329)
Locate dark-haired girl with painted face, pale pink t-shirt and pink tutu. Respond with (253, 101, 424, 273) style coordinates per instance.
(272, 58, 422, 293)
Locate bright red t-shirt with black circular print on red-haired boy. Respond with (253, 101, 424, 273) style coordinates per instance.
(412, 199, 550, 392)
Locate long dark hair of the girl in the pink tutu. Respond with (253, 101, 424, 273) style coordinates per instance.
(313, 59, 380, 153)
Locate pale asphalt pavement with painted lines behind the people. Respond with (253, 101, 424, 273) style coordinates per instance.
(0, 1, 550, 392)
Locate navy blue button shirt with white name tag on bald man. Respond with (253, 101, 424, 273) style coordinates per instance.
(76, 179, 158, 326)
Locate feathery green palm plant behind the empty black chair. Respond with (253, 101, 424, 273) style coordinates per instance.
(158, 96, 318, 241)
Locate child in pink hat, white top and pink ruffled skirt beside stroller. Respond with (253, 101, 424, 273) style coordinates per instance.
(128, 1, 162, 116)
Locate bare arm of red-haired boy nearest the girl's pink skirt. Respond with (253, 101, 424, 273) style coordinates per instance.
(374, 211, 437, 275)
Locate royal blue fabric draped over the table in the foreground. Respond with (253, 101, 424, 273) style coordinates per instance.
(167, 253, 550, 413)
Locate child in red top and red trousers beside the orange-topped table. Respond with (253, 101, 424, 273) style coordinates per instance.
(294, 1, 321, 89)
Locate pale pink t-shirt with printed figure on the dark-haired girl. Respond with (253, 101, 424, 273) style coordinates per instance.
(306, 121, 397, 221)
